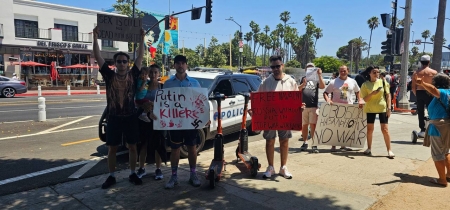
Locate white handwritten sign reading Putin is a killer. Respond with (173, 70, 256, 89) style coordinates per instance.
(153, 87, 209, 130)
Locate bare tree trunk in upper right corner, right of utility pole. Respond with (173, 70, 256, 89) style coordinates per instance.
(431, 0, 447, 72)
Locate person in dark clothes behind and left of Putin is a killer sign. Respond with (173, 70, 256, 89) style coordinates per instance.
(136, 65, 167, 180)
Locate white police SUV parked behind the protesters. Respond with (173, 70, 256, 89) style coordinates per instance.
(99, 71, 262, 158)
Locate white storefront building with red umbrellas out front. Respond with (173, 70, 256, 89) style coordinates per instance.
(0, 0, 128, 86)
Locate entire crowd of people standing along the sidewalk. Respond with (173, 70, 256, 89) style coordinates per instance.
(93, 24, 450, 189)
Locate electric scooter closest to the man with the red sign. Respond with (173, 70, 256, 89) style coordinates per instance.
(236, 93, 261, 177)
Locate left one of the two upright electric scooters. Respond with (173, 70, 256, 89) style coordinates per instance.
(206, 93, 234, 189)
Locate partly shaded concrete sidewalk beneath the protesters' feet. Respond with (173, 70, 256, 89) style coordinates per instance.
(0, 114, 450, 210)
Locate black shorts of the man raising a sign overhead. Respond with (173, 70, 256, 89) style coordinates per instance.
(106, 114, 139, 146)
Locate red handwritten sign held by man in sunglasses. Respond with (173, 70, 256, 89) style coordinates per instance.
(251, 91, 302, 130)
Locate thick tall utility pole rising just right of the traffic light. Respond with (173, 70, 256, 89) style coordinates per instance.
(400, 0, 412, 110)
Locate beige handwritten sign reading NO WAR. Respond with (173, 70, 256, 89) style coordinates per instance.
(312, 103, 367, 148)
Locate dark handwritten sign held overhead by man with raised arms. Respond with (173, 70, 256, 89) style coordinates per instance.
(97, 14, 142, 42)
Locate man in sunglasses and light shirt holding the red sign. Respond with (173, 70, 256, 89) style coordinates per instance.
(249, 55, 298, 179)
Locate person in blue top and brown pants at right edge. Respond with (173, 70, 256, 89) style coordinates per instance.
(413, 73, 450, 187)
